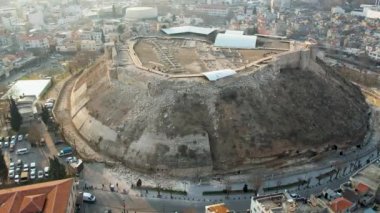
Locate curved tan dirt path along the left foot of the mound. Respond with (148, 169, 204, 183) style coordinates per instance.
(54, 74, 105, 162)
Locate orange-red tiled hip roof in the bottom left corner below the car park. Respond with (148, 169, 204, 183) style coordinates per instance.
(0, 178, 74, 213)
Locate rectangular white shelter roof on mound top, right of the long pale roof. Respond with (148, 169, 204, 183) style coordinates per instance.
(214, 33, 257, 49)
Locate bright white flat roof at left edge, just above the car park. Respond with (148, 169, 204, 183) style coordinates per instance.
(1, 79, 51, 99)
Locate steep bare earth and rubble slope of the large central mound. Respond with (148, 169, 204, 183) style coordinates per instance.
(81, 57, 369, 174)
